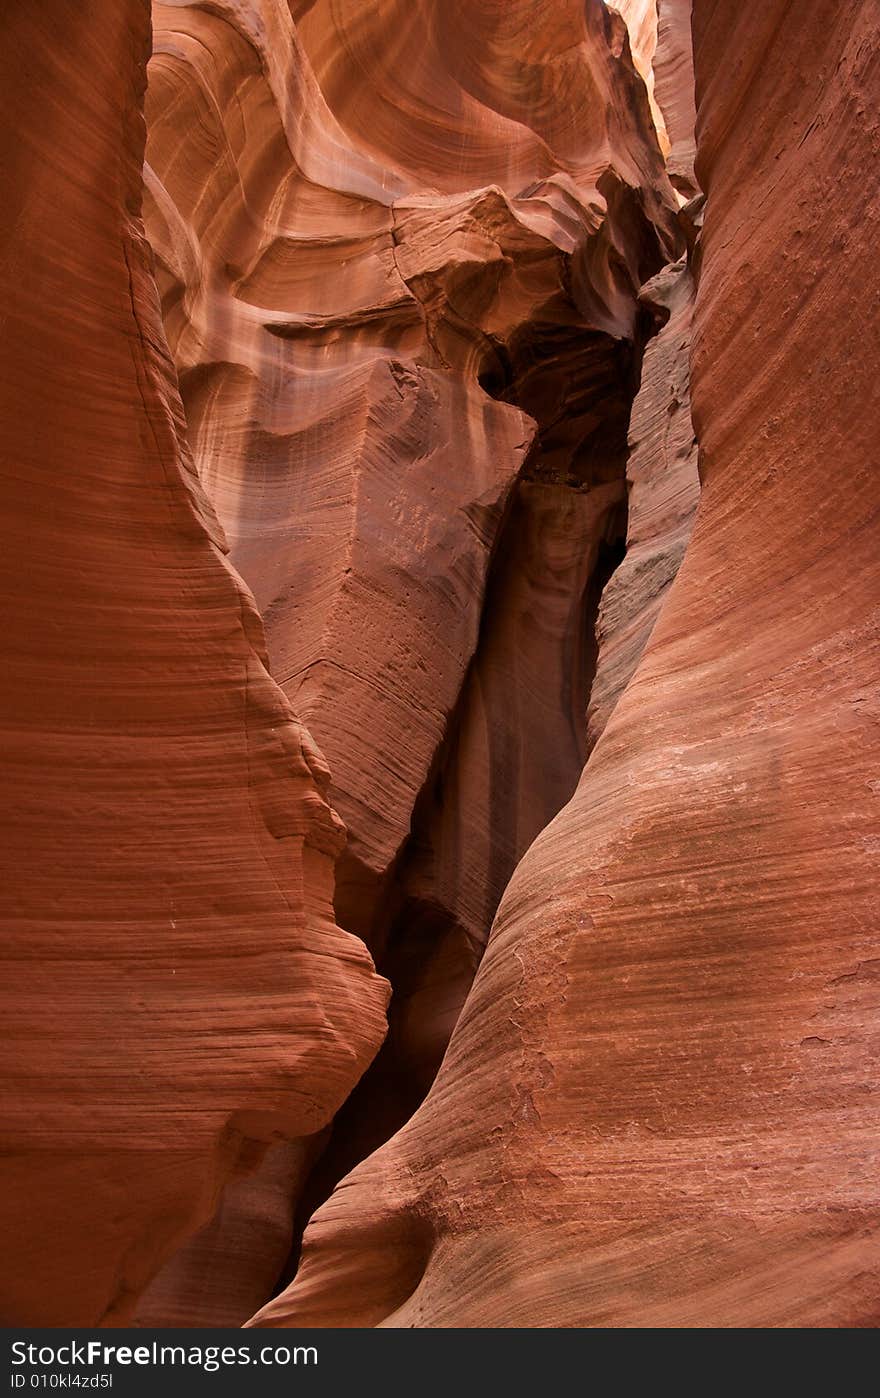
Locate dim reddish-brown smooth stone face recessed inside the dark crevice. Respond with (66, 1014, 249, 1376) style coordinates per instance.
(386, 481, 624, 1095)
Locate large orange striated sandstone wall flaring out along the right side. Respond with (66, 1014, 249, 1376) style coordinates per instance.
(257, 0, 880, 1327)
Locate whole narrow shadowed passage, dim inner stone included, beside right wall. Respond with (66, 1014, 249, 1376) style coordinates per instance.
(281, 334, 646, 1280)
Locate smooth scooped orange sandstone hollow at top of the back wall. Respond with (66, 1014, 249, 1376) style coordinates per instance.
(297, 0, 671, 200)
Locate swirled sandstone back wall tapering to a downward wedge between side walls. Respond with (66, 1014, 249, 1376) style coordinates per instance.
(147, 0, 676, 944)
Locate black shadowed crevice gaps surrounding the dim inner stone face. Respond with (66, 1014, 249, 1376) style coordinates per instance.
(270, 317, 656, 1290)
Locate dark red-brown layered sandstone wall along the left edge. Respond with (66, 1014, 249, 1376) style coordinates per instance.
(0, 0, 385, 1325)
